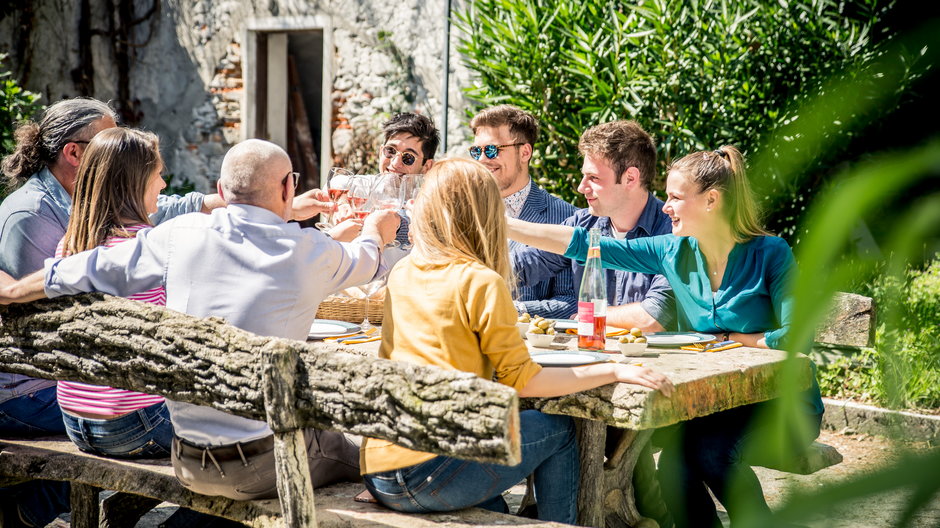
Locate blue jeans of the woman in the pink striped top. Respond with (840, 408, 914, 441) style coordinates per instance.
(62, 403, 173, 458)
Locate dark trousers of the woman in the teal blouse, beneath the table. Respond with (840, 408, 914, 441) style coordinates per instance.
(653, 400, 822, 528)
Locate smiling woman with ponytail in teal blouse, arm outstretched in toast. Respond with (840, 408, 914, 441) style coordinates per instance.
(509, 146, 823, 527)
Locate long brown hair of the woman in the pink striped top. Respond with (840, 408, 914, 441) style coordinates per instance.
(63, 128, 163, 255)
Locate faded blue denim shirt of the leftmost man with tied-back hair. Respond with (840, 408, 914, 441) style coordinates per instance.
(0, 167, 204, 403)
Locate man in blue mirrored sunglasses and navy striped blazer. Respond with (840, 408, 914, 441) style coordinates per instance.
(470, 105, 578, 318)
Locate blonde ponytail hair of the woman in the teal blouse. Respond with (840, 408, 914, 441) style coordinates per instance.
(669, 145, 770, 242)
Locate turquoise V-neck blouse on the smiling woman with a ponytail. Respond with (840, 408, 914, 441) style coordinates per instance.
(565, 227, 823, 413)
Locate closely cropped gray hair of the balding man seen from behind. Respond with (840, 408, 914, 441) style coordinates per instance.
(219, 139, 289, 204)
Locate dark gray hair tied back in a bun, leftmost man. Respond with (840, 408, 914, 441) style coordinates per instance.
(0, 97, 118, 187)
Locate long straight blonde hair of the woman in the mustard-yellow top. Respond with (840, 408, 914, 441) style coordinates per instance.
(411, 159, 515, 289)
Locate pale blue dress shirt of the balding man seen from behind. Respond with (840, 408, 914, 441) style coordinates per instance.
(45, 204, 386, 446)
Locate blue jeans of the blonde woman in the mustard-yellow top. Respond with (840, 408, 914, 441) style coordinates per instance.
(363, 411, 581, 524)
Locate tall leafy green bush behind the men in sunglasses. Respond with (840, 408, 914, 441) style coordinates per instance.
(456, 0, 917, 235)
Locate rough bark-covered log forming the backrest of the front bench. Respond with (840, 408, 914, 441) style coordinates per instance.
(0, 294, 521, 464)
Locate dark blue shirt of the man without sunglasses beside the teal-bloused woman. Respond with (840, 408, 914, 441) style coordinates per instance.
(512, 193, 678, 330)
